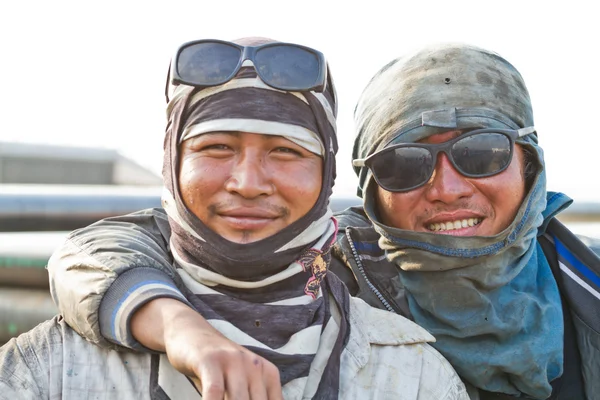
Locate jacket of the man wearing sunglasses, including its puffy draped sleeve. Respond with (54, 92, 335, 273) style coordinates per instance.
(48, 208, 600, 398)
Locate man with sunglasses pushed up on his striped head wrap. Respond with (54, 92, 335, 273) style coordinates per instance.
(0, 39, 468, 400)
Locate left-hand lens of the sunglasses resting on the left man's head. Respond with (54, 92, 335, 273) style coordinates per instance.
(177, 43, 241, 86)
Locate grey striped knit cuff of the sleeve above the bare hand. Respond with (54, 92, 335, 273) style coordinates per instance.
(98, 267, 191, 353)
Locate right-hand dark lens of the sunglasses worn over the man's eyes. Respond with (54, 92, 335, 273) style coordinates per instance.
(450, 133, 511, 176)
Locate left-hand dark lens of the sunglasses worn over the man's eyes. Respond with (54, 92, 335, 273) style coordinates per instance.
(370, 147, 434, 192)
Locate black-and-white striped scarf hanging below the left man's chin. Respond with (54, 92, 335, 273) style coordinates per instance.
(158, 223, 349, 399)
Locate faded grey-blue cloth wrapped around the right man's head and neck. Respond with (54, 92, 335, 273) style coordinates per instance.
(353, 44, 564, 398)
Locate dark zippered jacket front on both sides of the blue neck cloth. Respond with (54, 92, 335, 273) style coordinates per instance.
(334, 207, 600, 399)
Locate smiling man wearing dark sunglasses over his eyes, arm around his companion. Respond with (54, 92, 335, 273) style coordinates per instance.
(36, 45, 600, 399)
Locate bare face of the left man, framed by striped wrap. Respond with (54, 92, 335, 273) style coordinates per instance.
(179, 132, 323, 243)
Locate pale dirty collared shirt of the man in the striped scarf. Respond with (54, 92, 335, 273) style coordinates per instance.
(0, 292, 468, 400)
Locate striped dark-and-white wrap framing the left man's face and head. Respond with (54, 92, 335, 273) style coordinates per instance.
(163, 40, 337, 280)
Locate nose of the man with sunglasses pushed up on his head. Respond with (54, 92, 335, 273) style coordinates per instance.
(225, 153, 275, 199)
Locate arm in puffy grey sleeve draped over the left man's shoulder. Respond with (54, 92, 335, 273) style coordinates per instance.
(48, 209, 281, 399)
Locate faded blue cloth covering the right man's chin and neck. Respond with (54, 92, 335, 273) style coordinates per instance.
(365, 130, 571, 399)
